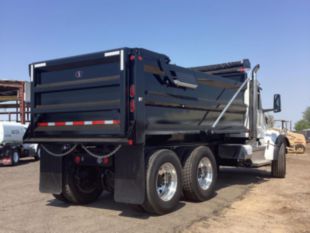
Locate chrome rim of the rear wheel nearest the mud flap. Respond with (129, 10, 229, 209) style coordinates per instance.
(156, 162, 178, 201)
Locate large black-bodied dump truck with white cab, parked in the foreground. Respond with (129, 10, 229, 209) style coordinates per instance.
(24, 48, 288, 214)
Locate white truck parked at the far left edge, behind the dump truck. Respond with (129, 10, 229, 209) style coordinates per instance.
(0, 121, 40, 166)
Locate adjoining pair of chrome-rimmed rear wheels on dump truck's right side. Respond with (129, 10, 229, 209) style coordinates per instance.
(143, 146, 217, 215)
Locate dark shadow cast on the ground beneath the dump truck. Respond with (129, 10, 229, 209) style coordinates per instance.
(47, 167, 270, 219)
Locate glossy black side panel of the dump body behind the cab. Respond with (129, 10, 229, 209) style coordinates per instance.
(139, 49, 247, 137)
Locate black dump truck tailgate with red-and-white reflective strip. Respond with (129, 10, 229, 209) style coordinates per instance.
(25, 50, 126, 142)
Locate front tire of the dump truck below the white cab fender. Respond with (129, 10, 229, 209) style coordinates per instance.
(271, 143, 286, 178)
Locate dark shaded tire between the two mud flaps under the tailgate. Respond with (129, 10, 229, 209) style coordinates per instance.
(62, 160, 103, 204)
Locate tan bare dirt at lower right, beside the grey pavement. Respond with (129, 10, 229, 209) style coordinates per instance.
(184, 145, 310, 233)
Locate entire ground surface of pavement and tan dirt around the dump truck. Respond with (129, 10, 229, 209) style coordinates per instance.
(0, 147, 310, 233)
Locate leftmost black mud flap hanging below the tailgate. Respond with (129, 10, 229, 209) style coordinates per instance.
(40, 147, 63, 194)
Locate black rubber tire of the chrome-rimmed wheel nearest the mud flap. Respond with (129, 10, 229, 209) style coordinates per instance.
(142, 149, 182, 215)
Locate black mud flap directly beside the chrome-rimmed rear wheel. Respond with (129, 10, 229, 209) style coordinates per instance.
(114, 145, 145, 204)
